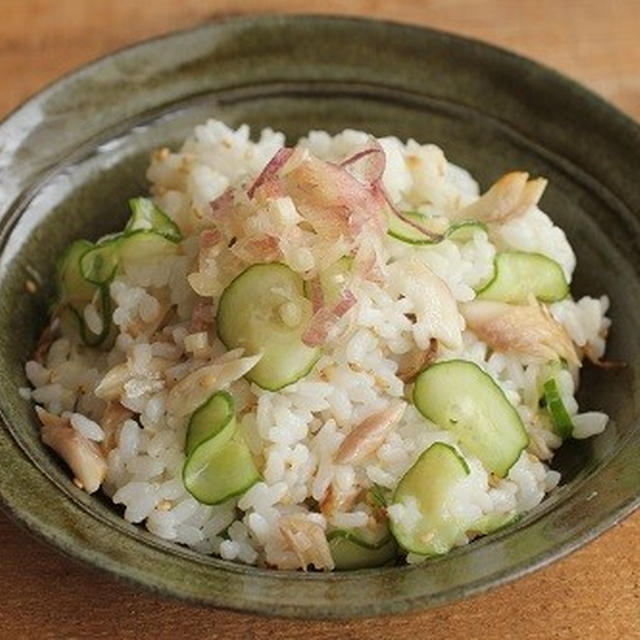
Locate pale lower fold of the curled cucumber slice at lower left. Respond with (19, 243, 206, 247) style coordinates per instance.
(182, 429, 260, 504)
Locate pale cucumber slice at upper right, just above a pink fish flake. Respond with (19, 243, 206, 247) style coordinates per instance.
(477, 251, 569, 304)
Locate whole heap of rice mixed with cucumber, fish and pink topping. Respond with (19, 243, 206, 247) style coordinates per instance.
(21, 120, 610, 570)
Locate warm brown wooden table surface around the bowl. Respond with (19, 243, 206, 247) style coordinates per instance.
(0, 0, 640, 640)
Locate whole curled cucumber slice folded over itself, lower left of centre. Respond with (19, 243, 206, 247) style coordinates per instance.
(182, 391, 260, 504)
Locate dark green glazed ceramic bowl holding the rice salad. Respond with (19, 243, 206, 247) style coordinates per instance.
(0, 16, 640, 618)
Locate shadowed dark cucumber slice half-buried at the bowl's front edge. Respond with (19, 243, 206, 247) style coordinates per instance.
(327, 529, 398, 570)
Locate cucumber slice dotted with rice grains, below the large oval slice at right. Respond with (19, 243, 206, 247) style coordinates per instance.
(389, 442, 469, 556)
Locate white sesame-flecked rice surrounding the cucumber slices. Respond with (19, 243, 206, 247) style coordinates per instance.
(21, 121, 609, 569)
